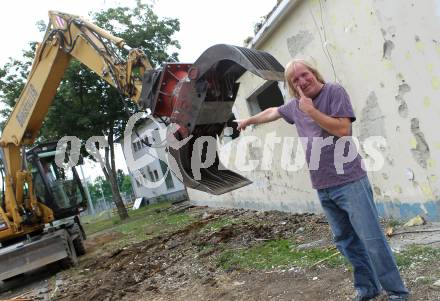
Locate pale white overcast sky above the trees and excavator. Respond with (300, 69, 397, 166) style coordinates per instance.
(0, 0, 277, 179)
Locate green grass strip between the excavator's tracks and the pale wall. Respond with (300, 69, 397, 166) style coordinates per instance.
(82, 202, 195, 246)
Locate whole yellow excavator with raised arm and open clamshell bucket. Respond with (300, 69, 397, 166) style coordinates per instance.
(0, 11, 284, 281)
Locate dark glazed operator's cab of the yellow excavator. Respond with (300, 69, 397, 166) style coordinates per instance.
(27, 142, 87, 220)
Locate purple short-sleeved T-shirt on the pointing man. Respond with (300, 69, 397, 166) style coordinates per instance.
(278, 83, 366, 189)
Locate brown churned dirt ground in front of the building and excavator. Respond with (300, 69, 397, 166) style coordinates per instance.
(0, 207, 440, 301)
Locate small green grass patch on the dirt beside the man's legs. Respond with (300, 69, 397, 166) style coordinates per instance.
(218, 239, 345, 270)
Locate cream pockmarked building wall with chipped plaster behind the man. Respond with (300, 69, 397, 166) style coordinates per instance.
(189, 0, 440, 220)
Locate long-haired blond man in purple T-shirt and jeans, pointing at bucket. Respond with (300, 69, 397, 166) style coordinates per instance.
(237, 60, 408, 301)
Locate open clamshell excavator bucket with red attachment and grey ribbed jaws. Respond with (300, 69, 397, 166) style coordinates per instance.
(140, 44, 284, 195)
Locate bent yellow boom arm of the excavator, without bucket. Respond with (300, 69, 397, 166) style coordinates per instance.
(0, 11, 152, 147)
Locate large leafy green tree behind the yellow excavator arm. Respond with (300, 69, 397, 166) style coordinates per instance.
(0, 0, 179, 219)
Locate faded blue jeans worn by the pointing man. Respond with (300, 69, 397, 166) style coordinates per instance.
(318, 176, 408, 296)
